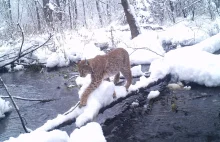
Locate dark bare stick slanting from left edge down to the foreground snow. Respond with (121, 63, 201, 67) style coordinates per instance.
(0, 77, 30, 133)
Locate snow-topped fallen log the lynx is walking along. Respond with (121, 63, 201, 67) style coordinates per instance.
(36, 75, 170, 131)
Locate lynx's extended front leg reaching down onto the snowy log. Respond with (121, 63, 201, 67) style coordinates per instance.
(79, 80, 102, 107)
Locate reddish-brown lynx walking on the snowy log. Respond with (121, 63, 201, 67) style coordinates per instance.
(77, 48, 132, 107)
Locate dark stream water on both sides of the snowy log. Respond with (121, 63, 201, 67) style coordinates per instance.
(0, 67, 220, 142)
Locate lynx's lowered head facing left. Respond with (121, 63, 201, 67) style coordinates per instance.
(77, 59, 93, 77)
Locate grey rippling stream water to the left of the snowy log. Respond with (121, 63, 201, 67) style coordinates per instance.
(0, 68, 79, 141)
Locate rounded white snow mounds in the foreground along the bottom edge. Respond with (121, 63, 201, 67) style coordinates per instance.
(5, 122, 106, 142)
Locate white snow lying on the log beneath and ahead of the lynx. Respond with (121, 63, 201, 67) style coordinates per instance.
(36, 75, 127, 131)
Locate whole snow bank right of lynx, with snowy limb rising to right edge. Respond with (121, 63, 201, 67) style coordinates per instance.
(129, 34, 220, 91)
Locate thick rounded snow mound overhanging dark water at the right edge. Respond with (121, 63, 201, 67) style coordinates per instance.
(162, 48, 220, 87)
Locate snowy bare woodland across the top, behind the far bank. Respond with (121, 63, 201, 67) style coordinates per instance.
(0, 0, 220, 39)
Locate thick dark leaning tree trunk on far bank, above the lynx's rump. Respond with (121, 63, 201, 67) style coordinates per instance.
(121, 0, 141, 39)
